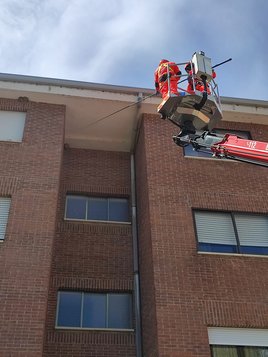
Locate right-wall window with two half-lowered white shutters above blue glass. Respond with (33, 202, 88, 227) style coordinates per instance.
(194, 210, 268, 255)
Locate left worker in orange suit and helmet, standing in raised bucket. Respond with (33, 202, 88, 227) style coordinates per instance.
(154, 59, 181, 99)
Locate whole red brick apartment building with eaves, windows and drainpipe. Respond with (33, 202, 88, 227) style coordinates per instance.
(0, 74, 268, 357)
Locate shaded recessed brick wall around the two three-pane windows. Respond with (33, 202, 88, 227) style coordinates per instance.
(44, 149, 135, 357)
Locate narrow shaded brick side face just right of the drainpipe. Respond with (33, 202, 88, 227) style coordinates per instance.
(135, 122, 158, 357)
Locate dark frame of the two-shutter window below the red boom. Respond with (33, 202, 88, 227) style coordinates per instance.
(192, 208, 268, 257)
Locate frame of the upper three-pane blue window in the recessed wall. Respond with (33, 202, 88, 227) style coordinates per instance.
(64, 193, 131, 225)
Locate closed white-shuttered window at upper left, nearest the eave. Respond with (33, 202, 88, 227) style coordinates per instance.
(0, 111, 26, 142)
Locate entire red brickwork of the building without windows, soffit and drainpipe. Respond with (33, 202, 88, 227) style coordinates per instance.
(0, 99, 268, 357)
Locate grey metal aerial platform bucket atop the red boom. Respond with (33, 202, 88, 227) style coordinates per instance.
(157, 52, 222, 132)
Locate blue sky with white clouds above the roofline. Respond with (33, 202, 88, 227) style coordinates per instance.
(0, 0, 268, 100)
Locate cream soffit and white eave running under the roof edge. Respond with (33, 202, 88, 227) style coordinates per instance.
(0, 73, 268, 151)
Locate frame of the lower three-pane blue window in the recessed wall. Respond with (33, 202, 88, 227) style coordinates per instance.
(55, 289, 134, 331)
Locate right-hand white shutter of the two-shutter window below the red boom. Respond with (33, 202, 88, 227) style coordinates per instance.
(235, 213, 268, 247)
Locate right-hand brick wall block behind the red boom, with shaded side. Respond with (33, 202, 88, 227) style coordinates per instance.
(136, 115, 268, 357)
